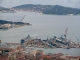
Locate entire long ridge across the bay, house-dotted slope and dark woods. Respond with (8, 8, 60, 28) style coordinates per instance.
(13, 4, 80, 15)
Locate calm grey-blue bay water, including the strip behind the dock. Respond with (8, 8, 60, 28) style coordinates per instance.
(0, 12, 80, 55)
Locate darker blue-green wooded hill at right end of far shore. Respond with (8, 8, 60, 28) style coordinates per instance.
(43, 5, 80, 15)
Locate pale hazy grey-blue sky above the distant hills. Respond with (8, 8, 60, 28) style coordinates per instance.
(0, 0, 80, 8)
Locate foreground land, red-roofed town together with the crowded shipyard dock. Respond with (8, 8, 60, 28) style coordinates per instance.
(0, 35, 80, 60)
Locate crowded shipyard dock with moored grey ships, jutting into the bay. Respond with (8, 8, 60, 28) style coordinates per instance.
(21, 35, 80, 49)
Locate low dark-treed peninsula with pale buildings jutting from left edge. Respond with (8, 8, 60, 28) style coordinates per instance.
(0, 20, 31, 29)
